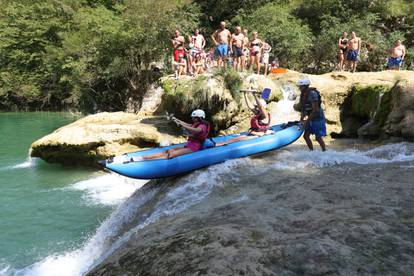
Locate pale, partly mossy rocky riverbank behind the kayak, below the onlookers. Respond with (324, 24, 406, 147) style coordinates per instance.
(31, 71, 414, 165)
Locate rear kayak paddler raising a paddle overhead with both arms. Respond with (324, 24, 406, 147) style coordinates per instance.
(216, 93, 271, 147)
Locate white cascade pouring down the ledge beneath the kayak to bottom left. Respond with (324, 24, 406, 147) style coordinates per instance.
(15, 159, 248, 276)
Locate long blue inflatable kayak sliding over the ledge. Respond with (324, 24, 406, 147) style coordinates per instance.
(100, 122, 303, 179)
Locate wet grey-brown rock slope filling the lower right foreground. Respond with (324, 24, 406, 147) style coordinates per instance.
(88, 144, 414, 275)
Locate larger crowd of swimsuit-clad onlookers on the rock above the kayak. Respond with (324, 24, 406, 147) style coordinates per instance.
(171, 21, 278, 78)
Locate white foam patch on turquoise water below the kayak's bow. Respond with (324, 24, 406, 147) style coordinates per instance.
(70, 173, 148, 205)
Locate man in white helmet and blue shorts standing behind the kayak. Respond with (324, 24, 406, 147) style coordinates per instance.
(297, 78, 326, 151)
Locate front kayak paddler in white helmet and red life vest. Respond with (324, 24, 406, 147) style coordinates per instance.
(142, 109, 210, 161)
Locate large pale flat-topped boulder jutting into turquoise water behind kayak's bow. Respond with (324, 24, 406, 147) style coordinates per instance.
(31, 112, 183, 165)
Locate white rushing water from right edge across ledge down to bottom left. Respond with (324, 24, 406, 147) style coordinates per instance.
(16, 143, 414, 276)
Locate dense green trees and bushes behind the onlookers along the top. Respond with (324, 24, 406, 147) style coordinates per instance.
(0, 0, 414, 112)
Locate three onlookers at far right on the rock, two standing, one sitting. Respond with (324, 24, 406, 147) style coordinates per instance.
(338, 32, 406, 72)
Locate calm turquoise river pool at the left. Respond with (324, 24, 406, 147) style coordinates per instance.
(0, 113, 114, 274)
